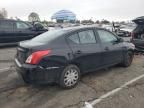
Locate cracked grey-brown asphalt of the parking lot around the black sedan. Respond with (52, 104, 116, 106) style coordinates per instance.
(0, 47, 144, 108)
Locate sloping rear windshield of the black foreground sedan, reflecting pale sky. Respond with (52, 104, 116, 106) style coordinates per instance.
(31, 30, 66, 43)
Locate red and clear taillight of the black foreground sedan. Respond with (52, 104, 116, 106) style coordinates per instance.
(26, 50, 51, 64)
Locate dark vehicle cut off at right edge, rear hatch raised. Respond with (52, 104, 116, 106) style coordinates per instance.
(132, 16, 144, 52)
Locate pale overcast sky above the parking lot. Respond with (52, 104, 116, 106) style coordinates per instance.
(0, 0, 144, 21)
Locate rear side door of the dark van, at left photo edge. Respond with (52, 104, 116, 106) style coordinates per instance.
(0, 20, 15, 43)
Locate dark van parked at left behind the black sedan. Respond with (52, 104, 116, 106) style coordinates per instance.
(0, 19, 47, 45)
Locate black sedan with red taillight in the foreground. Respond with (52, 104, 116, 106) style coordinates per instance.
(15, 26, 134, 88)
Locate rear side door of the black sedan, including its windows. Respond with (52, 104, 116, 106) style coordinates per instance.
(69, 29, 101, 72)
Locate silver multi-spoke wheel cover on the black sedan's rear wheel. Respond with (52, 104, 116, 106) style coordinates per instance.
(64, 69, 79, 87)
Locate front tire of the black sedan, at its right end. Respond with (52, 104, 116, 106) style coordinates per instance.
(122, 51, 134, 67)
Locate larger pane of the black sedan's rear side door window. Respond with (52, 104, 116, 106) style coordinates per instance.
(78, 30, 96, 44)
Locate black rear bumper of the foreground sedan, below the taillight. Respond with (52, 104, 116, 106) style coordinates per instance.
(15, 59, 63, 84)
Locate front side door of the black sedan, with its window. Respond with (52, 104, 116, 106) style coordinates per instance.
(97, 29, 123, 65)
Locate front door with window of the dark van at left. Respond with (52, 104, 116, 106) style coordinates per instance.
(14, 21, 37, 41)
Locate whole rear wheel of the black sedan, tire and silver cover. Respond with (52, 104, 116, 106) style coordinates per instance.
(59, 65, 80, 89)
